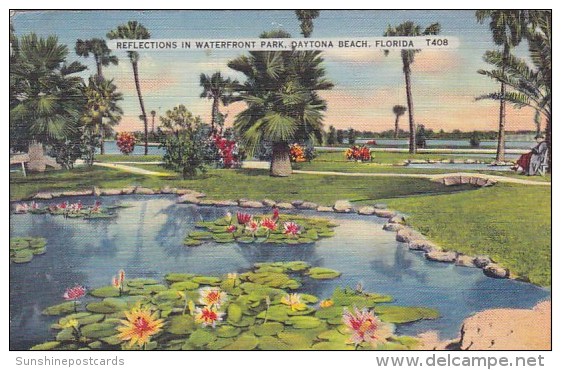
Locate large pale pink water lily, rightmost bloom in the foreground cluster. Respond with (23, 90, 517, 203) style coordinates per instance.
(343, 307, 392, 346)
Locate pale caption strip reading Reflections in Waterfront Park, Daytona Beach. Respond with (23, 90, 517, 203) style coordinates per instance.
(108, 36, 458, 51)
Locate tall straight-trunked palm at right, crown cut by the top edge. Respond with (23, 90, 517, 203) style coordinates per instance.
(475, 10, 525, 162)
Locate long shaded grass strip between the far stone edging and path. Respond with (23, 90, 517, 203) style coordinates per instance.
(10, 165, 471, 205)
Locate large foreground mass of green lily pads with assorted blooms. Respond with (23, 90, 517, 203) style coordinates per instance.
(32, 261, 438, 350)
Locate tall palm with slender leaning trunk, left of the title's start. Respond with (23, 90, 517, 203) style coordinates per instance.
(107, 21, 150, 155)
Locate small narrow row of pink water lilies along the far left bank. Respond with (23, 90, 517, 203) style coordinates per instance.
(14, 201, 128, 219)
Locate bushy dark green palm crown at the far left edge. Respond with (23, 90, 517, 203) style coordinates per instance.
(10, 33, 86, 151)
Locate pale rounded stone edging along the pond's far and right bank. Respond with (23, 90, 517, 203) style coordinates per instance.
(20, 188, 516, 279)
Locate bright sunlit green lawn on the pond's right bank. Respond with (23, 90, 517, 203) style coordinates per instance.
(387, 184, 551, 286)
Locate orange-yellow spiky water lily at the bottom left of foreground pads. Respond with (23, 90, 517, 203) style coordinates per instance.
(117, 307, 164, 347)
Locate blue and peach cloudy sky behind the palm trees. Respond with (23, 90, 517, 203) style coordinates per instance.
(9, 10, 533, 131)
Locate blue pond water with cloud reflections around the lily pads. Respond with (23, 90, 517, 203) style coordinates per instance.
(10, 195, 550, 350)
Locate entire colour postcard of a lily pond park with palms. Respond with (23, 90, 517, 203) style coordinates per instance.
(9, 9, 553, 354)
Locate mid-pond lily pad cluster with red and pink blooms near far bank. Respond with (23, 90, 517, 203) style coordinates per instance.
(184, 210, 337, 247)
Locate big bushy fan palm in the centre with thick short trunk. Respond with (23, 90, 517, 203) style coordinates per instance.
(228, 31, 333, 177)
